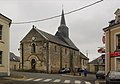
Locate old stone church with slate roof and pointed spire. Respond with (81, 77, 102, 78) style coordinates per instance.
(20, 10, 80, 73)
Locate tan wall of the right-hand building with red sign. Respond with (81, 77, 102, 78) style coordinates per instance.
(105, 25, 120, 72)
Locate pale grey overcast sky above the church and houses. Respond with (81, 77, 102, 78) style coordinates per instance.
(0, 0, 120, 61)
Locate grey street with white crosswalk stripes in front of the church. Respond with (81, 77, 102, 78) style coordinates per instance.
(0, 72, 104, 84)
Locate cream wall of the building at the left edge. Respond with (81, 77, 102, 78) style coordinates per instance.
(0, 15, 10, 76)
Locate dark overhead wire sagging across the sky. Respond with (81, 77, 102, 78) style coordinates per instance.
(12, 0, 103, 24)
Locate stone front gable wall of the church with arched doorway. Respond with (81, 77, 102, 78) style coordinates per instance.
(20, 30, 47, 71)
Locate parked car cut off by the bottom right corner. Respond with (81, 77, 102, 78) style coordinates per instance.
(106, 71, 120, 84)
